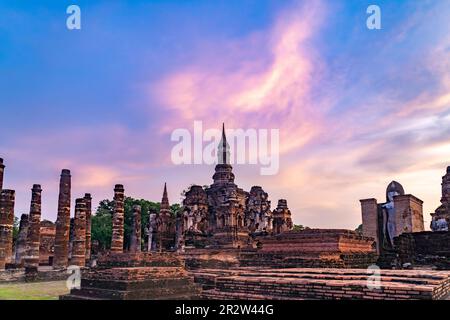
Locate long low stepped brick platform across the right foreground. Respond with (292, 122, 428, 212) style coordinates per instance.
(194, 268, 450, 300)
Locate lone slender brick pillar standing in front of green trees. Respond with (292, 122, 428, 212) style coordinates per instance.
(111, 184, 125, 253)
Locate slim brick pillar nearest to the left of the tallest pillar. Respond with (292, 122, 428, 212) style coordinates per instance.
(24, 184, 42, 274)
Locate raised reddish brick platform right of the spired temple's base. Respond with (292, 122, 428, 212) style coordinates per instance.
(239, 229, 378, 268)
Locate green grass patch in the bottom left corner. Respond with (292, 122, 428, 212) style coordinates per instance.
(0, 281, 69, 300)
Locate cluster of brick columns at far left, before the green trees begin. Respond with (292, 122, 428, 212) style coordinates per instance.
(0, 158, 92, 272)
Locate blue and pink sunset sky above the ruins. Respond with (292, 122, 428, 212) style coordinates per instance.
(0, 0, 450, 229)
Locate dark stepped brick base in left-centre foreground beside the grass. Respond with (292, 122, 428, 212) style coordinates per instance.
(60, 252, 201, 300)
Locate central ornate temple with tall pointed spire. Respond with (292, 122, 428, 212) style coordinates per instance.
(177, 127, 293, 249)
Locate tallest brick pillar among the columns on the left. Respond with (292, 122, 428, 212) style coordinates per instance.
(53, 169, 71, 269)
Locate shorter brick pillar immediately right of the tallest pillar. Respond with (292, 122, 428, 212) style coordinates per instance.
(70, 198, 86, 267)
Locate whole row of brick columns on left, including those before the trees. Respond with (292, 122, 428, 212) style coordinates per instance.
(0, 159, 141, 272)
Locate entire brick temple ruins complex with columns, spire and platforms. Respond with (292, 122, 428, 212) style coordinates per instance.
(0, 150, 450, 300)
